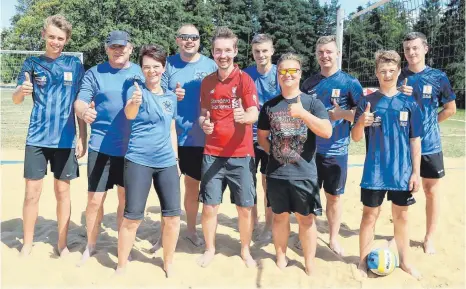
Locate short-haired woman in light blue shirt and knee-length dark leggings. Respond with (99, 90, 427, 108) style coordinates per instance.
(117, 45, 181, 277)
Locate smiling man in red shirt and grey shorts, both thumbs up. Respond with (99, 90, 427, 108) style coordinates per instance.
(198, 27, 259, 267)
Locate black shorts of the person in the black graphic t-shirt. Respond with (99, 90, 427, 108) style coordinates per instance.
(267, 177, 322, 216)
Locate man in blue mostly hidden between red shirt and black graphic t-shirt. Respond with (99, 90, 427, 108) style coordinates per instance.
(244, 34, 280, 242)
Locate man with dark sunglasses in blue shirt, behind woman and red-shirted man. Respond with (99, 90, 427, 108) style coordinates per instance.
(152, 24, 217, 251)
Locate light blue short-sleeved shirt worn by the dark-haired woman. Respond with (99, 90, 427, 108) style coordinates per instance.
(125, 83, 177, 168)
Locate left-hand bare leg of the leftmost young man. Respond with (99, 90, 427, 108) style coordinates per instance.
(20, 179, 43, 256)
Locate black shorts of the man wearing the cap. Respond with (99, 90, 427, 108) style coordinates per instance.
(87, 149, 125, 192)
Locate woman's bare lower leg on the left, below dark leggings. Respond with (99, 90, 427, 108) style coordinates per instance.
(116, 218, 142, 274)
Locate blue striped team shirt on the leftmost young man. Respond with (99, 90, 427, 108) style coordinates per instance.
(17, 55, 84, 148)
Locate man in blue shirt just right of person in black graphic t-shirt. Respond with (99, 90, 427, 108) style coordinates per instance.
(298, 35, 363, 255)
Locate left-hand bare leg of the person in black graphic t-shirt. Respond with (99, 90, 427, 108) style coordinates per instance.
(272, 213, 290, 269)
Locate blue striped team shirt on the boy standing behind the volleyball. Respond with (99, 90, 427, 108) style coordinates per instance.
(354, 91, 423, 191)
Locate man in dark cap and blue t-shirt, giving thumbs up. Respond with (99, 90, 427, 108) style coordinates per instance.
(75, 31, 143, 266)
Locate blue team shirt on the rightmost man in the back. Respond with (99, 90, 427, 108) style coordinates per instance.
(398, 66, 456, 155)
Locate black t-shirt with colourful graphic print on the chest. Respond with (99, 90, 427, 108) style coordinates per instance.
(257, 93, 328, 180)
